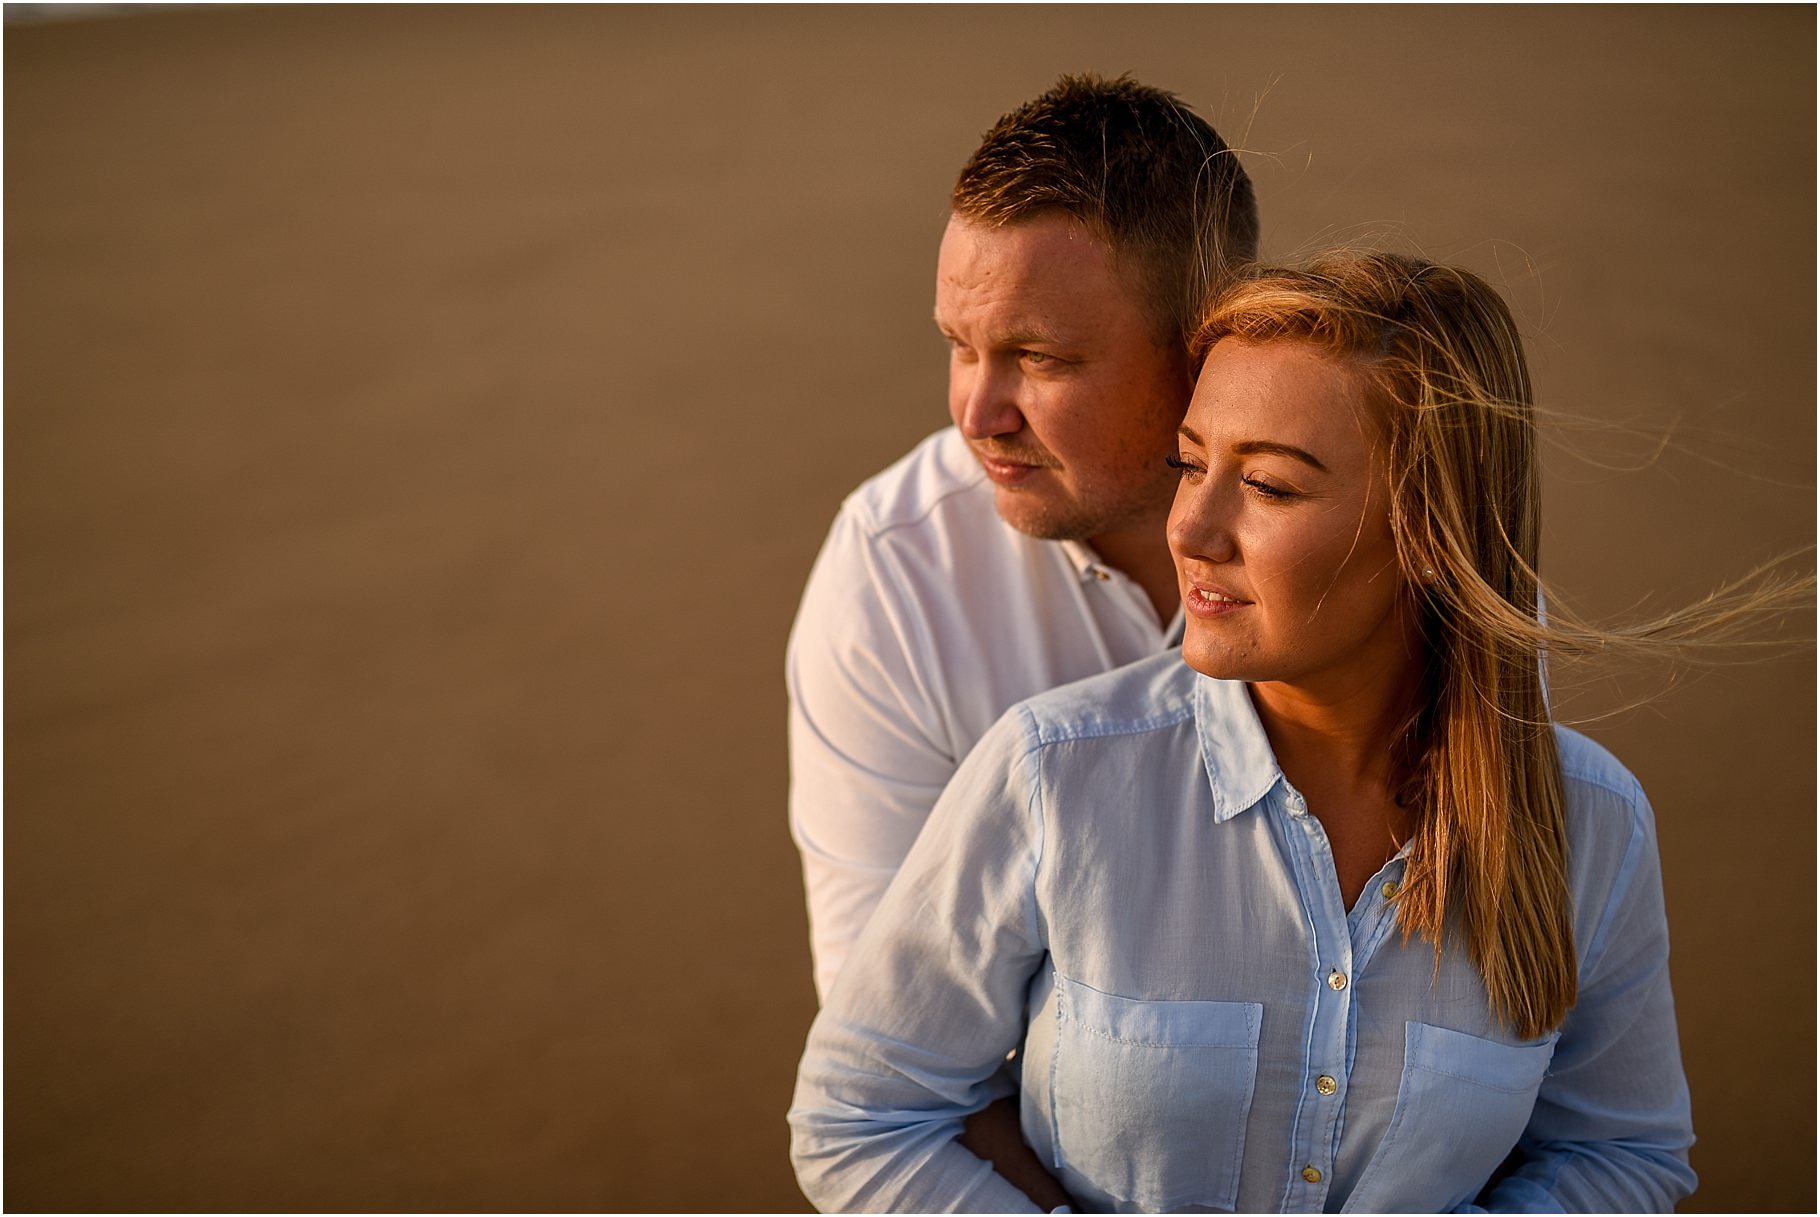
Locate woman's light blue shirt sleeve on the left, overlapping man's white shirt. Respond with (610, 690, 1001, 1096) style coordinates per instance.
(790, 711, 1047, 1213)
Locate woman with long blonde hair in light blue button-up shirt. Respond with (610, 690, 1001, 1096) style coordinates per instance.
(790, 255, 1694, 1212)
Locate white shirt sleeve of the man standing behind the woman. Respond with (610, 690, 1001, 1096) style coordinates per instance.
(784, 504, 957, 999)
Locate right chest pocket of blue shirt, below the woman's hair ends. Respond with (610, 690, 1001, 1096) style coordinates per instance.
(1341, 1022, 1560, 1213)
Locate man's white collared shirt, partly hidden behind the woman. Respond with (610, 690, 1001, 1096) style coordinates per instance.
(786, 427, 1181, 995)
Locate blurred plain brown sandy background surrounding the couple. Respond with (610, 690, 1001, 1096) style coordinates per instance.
(4, 5, 1816, 1212)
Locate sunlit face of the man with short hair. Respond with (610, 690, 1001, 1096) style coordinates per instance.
(935, 213, 1194, 540)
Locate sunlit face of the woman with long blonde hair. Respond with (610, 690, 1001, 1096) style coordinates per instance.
(1168, 338, 1418, 697)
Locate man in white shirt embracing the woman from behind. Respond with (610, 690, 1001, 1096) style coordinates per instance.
(786, 76, 1258, 1204)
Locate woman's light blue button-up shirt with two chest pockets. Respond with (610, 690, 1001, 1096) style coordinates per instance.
(790, 655, 1694, 1212)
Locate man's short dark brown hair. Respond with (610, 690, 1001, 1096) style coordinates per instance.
(950, 75, 1258, 342)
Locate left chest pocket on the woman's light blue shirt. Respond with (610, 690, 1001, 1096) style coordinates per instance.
(1050, 975, 1263, 1212)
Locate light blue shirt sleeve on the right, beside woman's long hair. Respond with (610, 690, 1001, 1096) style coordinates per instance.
(1480, 774, 1694, 1213)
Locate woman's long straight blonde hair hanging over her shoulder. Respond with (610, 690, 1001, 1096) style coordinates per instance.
(1192, 253, 1578, 1037)
